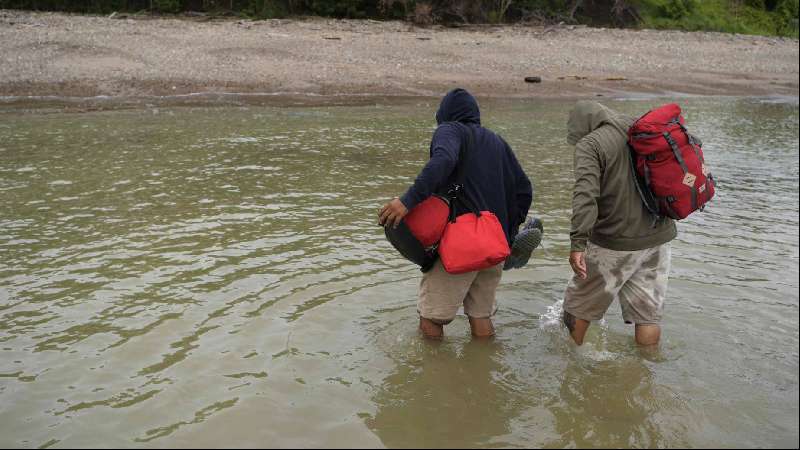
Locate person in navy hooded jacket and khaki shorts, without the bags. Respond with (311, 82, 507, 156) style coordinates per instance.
(379, 89, 533, 337)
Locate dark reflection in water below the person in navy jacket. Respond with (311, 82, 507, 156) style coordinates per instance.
(367, 340, 522, 448)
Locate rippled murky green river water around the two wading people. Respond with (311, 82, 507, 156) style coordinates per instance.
(0, 98, 799, 448)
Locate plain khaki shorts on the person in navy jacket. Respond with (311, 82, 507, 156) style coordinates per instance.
(417, 260, 503, 322)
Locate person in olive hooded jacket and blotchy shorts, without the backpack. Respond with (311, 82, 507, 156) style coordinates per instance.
(564, 101, 677, 344)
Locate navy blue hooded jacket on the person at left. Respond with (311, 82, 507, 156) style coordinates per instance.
(400, 89, 533, 245)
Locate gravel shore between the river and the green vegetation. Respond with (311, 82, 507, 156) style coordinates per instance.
(0, 10, 798, 102)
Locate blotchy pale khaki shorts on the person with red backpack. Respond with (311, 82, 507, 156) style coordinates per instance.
(564, 242, 671, 325)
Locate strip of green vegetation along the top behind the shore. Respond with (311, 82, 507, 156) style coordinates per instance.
(0, 0, 800, 37)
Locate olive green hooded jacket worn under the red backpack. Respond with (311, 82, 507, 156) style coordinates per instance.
(567, 101, 677, 252)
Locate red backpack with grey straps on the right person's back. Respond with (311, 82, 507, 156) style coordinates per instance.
(628, 103, 716, 220)
